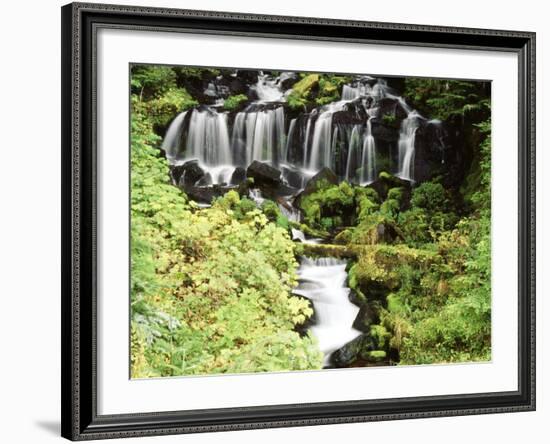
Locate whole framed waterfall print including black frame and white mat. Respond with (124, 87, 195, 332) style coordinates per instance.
(62, 3, 535, 440)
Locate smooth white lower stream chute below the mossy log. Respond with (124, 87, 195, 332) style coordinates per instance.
(295, 257, 361, 366)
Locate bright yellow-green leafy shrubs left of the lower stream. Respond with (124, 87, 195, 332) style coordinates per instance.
(131, 81, 322, 378)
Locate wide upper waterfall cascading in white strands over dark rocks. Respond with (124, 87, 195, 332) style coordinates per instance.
(162, 72, 434, 188)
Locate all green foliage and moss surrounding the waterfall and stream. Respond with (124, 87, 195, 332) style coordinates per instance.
(131, 65, 491, 377)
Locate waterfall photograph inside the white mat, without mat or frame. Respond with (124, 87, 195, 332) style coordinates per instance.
(129, 64, 491, 378)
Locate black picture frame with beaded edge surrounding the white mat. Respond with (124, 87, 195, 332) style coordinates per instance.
(61, 3, 535, 440)
